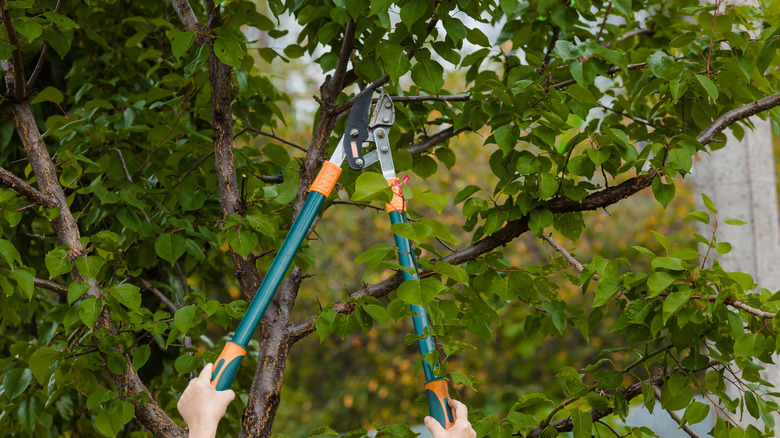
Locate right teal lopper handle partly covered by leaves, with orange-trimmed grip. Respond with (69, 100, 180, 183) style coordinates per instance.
(388, 211, 454, 429)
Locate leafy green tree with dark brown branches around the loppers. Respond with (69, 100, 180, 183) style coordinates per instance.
(0, 0, 780, 437)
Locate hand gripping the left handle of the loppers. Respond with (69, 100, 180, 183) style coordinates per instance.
(176, 364, 236, 438)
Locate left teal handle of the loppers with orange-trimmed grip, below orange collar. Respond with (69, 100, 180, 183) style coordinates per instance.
(211, 192, 325, 390)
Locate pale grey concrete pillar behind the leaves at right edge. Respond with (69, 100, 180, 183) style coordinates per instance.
(694, 117, 780, 430)
